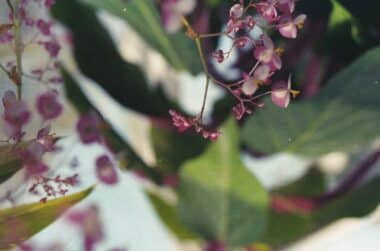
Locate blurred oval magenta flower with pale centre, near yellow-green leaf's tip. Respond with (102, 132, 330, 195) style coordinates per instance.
(96, 155, 118, 185)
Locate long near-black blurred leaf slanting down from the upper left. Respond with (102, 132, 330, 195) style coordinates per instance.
(52, 0, 175, 116)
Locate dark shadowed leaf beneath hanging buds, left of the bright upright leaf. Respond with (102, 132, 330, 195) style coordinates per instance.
(151, 125, 207, 174)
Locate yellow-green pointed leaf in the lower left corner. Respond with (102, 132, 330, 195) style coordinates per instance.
(0, 187, 93, 249)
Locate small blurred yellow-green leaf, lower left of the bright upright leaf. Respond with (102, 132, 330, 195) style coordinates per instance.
(147, 193, 199, 240)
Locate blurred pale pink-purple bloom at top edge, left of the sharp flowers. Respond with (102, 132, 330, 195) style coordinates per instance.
(161, 0, 196, 33)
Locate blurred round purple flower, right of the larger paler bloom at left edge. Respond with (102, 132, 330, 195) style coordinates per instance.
(37, 91, 63, 120)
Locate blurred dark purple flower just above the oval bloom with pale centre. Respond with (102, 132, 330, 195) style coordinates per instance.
(76, 113, 101, 144)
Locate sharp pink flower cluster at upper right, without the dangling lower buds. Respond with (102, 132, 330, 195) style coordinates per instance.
(213, 0, 306, 120)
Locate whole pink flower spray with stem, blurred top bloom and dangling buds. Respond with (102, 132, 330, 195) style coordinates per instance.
(162, 0, 306, 140)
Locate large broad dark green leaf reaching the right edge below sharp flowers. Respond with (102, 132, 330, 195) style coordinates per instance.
(241, 48, 380, 156)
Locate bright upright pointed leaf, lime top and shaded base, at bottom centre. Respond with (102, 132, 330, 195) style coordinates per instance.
(179, 119, 268, 246)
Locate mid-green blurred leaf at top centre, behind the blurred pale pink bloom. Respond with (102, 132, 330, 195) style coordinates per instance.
(83, 0, 201, 74)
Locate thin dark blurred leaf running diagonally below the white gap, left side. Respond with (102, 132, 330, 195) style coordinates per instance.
(62, 69, 159, 182)
